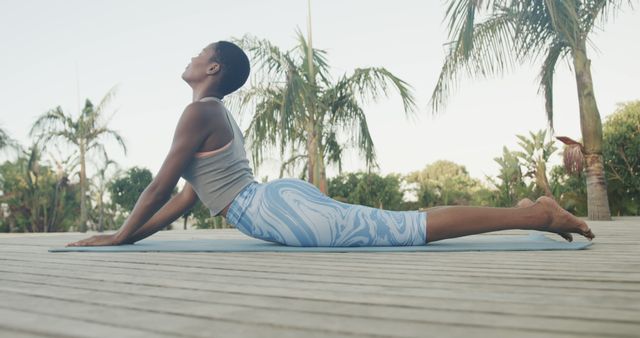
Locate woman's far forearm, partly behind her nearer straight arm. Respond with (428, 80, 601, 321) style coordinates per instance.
(122, 183, 198, 244)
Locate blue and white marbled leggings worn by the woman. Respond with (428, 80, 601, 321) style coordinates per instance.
(222, 179, 427, 246)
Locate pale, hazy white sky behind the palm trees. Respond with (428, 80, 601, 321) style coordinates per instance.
(0, 0, 640, 185)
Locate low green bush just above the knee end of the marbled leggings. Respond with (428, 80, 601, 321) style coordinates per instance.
(328, 172, 404, 210)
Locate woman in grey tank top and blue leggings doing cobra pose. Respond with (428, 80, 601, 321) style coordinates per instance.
(68, 41, 595, 246)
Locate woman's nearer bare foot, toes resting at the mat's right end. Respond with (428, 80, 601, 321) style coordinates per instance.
(536, 196, 596, 242)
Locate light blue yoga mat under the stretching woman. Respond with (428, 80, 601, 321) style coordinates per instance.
(49, 232, 591, 252)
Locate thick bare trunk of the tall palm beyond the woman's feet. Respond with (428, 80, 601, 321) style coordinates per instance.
(572, 41, 611, 220)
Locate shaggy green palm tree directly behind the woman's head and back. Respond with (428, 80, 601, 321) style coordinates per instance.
(237, 32, 415, 193)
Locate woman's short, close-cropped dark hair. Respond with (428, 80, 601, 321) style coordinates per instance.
(213, 41, 251, 95)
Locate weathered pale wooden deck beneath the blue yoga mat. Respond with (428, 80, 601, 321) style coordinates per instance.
(0, 217, 640, 337)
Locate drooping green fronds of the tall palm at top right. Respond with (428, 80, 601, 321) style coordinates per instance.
(431, 0, 633, 126)
